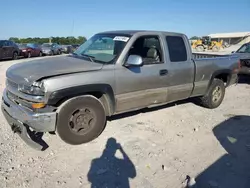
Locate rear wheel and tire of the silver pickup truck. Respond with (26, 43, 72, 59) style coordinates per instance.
(200, 79, 226, 109)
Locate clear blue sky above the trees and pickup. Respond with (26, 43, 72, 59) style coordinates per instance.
(0, 0, 250, 39)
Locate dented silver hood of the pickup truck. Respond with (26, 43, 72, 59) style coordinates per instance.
(6, 55, 103, 84)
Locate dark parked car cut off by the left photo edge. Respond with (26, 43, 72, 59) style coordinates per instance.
(0, 40, 20, 59)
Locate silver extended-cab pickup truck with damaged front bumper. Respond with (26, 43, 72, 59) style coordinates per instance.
(2, 31, 239, 149)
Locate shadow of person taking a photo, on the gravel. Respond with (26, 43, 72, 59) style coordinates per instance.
(87, 138, 136, 188)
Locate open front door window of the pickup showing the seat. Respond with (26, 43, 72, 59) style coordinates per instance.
(129, 36, 163, 65)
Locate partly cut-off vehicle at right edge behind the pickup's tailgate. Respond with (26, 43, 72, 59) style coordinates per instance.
(232, 42, 250, 75)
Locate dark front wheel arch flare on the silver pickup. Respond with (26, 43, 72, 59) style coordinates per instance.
(48, 84, 115, 116)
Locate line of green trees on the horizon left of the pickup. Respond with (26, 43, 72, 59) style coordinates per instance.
(9, 36, 87, 45)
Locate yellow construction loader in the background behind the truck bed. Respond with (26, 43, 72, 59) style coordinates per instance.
(192, 36, 226, 52)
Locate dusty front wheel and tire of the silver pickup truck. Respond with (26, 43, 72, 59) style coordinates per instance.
(56, 95, 106, 145)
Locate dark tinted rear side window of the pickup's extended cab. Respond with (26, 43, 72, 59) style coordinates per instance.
(166, 36, 187, 62)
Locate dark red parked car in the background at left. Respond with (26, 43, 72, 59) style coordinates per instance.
(18, 43, 43, 58)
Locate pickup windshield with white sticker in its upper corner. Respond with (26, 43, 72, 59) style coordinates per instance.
(74, 34, 129, 63)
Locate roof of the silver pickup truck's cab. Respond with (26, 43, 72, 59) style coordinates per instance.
(98, 30, 184, 36)
